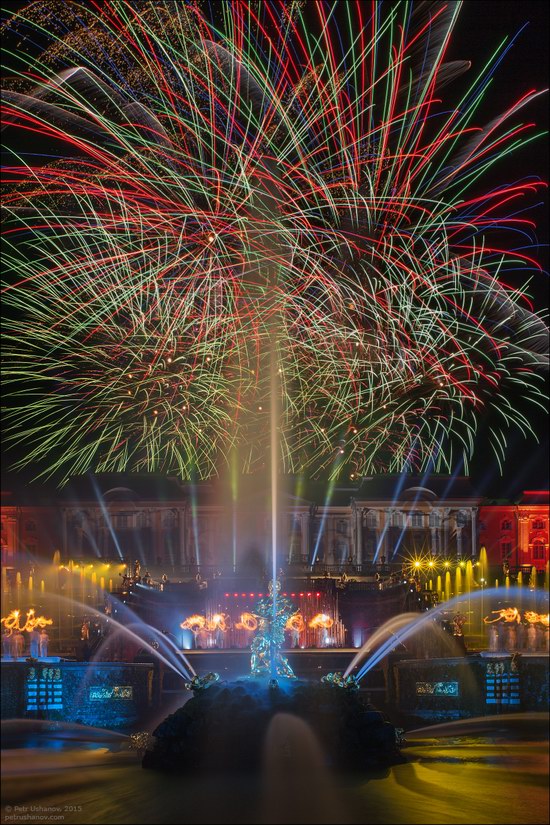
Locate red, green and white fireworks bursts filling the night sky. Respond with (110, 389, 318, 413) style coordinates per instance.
(3, 0, 546, 482)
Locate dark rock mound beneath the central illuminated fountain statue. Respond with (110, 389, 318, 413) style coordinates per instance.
(143, 679, 402, 772)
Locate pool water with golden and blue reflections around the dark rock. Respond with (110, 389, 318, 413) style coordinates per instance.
(2, 713, 548, 825)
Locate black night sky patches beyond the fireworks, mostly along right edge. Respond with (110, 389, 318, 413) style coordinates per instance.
(2, 0, 550, 497)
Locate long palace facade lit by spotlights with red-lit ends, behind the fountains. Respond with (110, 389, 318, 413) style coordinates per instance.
(1, 474, 549, 573)
